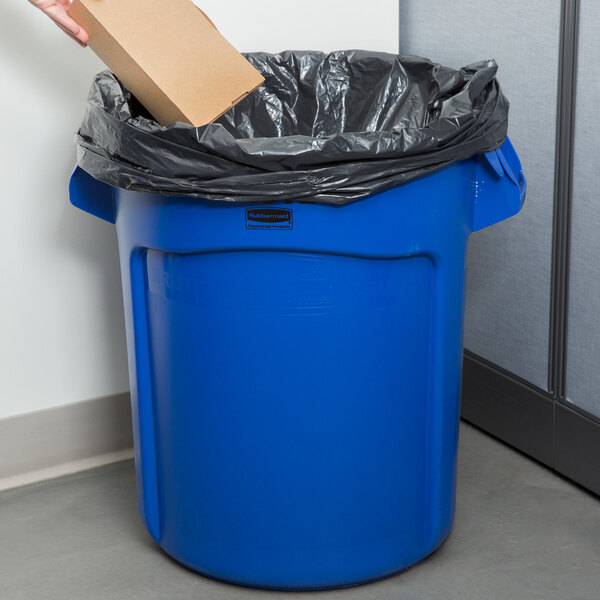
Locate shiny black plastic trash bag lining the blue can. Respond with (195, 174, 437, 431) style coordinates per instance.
(76, 50, 509, 205)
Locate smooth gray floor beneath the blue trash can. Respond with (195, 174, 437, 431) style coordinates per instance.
(0, 425, 600, 600)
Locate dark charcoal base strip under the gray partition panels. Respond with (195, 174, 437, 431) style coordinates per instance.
(461, 352, 600, 494)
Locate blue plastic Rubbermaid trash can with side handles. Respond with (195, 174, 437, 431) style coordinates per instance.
(70, 140, 525, 590)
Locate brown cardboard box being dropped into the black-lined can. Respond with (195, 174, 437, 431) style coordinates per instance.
(70, 0, 264, 127)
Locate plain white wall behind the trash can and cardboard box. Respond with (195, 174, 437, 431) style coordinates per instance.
(0, 0, 398, 418)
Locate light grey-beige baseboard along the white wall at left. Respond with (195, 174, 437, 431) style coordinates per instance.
(0, 393, 133, 490)
